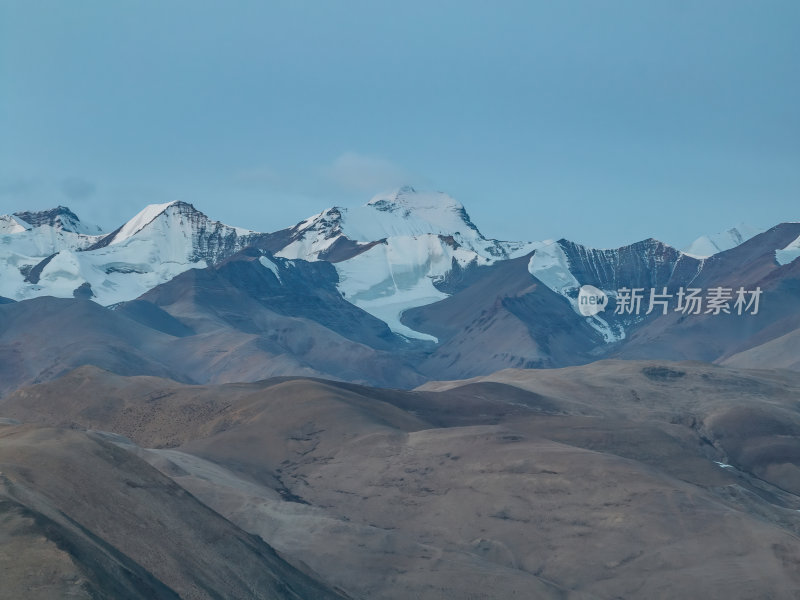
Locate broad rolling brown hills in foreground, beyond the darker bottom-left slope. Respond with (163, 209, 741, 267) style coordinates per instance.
(0, 361, 800, 599)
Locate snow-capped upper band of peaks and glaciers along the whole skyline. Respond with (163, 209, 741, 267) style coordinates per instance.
(0, 187, 799, 342)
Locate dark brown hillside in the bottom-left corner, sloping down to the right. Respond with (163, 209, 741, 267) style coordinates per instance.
(0, 424, 350, 600)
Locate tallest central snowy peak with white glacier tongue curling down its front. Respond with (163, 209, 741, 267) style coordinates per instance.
(277, 187, 540, 341)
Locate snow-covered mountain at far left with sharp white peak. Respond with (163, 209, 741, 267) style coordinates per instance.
(0, 202, 268, 305)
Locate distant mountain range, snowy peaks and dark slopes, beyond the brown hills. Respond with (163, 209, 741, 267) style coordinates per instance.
(0, 187, 800, 393)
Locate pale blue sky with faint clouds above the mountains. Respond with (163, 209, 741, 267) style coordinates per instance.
(0, 0, 800, 247)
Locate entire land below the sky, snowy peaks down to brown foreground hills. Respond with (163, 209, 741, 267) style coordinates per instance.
(0, 188, 800, 600)
